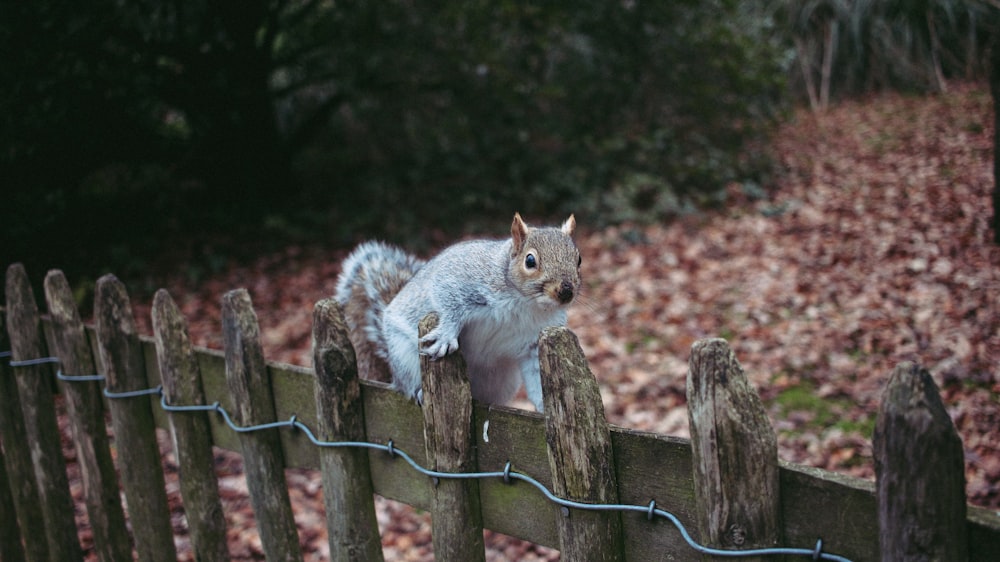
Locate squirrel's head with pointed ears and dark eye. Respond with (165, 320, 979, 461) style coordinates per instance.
(510, 213, 581, 306)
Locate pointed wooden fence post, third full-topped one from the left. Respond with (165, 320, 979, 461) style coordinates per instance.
(94, 275, 177, 562)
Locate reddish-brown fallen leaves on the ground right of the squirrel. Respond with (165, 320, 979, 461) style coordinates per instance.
(571, 83, 1000, 506)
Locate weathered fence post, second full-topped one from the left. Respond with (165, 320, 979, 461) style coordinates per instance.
(45, 270, 132, 561)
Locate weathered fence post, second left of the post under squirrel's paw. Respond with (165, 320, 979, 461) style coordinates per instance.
(222, 289, 302, 562)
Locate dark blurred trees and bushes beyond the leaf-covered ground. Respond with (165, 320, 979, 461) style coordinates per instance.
(0, 0, 1000, 284)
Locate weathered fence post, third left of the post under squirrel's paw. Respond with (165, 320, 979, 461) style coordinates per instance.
(152, 289, 229, 562)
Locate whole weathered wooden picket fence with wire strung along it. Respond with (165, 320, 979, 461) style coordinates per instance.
(0, 264, 1000, 562)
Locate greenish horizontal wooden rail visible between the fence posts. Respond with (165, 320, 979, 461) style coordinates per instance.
(72, 324, 1000, 560)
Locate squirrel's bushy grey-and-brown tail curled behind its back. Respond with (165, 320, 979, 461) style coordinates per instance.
(334, 242, 426, 382)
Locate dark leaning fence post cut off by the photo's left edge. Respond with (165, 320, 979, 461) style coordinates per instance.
(0, 306, 49, 561)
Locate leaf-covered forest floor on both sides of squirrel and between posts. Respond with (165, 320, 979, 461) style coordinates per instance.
(76, 81, 1000, 560)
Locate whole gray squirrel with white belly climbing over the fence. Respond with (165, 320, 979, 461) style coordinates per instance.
(335, 213, 581, 412)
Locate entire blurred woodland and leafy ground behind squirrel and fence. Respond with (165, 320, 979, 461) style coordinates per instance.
(0, 5, 1000, 548)
